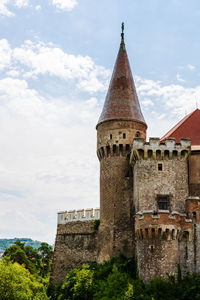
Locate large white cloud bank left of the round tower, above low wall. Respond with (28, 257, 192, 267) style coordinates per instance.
(0, 78, 100, 242)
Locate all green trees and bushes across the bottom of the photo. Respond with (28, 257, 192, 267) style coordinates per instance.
(0, 241, 200, 300)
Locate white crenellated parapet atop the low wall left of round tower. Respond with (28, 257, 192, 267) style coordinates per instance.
(58, 208, 100, 224)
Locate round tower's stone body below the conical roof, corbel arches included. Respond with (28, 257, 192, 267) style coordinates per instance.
(97, 120, 146, 262)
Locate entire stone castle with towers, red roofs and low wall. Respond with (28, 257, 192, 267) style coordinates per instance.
(51, 28, 200, 283)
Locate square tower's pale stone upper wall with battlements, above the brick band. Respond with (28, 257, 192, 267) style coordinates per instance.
(131, 138, 190, 212)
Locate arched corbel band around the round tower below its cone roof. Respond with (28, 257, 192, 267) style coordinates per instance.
(97, 144, 131, 160)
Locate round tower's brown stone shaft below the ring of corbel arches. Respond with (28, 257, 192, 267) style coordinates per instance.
(98, 156, 133, 261)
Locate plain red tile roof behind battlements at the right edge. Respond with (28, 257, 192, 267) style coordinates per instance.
(161, 109, 200, 146)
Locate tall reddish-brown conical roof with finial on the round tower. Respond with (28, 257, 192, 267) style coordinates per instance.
(97, 23, 146, 126)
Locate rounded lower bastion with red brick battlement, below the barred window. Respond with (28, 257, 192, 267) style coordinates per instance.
(135, 211, 197, 282)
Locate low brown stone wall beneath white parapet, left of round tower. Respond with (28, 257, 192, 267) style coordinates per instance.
(51, 221, 97, 284)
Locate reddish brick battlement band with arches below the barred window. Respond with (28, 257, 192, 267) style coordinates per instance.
(135, 210, 193, 241)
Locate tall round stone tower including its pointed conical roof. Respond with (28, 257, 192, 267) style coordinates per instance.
(96, 24, 147, 262)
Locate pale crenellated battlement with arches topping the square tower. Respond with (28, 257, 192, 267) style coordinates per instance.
(130, 138, 191, 163)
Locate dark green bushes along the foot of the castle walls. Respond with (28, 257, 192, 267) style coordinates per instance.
(49, 256, 200, 300)
